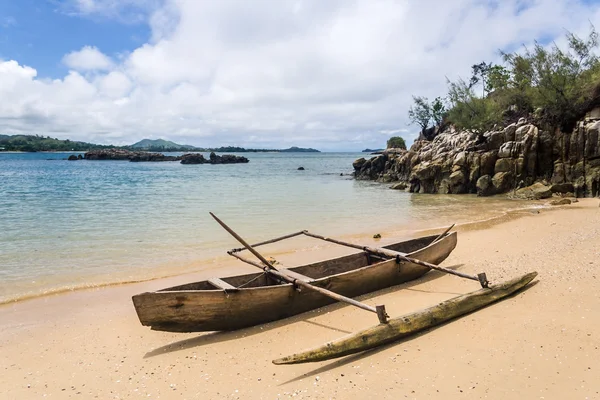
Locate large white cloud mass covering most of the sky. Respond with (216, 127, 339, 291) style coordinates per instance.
(0, 0, 600, 149)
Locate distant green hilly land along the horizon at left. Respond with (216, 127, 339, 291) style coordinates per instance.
(0, 135, 319, 153)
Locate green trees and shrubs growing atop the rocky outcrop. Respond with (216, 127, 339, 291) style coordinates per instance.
(408, 26, 600, 134)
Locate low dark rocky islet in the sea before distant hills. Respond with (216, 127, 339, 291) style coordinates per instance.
(83, 149, 250, 164)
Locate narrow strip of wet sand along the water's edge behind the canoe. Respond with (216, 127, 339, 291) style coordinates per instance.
(0, 200, 552, 307)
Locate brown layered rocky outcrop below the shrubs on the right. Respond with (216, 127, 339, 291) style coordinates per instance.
(353, 118, 600, 196)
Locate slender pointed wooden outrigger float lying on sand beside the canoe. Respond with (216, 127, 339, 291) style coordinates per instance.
(273, 272, 537, 365)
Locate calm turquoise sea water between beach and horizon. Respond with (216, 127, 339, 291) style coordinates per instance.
(0, 153, 536, 303)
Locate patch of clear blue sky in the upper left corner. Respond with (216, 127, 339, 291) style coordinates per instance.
(0, 0, 150, 78)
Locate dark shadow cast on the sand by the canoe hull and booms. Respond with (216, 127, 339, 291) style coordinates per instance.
(144, 264, 464, 358)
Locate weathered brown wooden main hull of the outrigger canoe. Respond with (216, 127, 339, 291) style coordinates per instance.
(133, 232, 457, 332)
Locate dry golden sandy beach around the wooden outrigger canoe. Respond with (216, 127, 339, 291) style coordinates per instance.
(0, 199, 600, 399)
